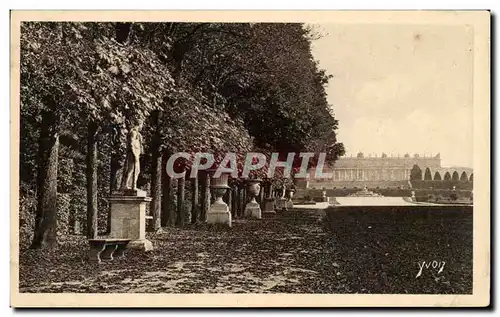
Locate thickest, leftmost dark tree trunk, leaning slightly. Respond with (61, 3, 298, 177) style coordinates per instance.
(31, 112, 59, 249)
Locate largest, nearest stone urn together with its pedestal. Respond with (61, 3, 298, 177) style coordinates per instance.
(207, 170, 231, 227)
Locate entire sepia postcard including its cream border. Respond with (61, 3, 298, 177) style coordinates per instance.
(10, 10, 490, 307)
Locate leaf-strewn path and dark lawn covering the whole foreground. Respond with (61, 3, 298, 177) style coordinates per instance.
(19, 206, 472, 294)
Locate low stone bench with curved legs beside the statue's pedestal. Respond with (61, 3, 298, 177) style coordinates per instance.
(89, 238, 130, 263)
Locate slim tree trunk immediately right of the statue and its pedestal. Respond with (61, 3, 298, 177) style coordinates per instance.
(150, 111, 162, 232)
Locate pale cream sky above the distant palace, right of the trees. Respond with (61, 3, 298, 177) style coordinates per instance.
(312, 23, 473, 167)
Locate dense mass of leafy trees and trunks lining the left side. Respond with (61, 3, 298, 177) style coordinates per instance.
(20, 22, 344, 248)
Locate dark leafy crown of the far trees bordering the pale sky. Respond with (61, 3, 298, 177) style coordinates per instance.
(184, 23, 344, 161)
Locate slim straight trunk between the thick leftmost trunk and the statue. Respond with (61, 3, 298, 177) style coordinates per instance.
(86, 122, 97, 239)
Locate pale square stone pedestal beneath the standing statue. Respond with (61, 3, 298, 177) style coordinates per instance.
(109, 190, 153, 251)
